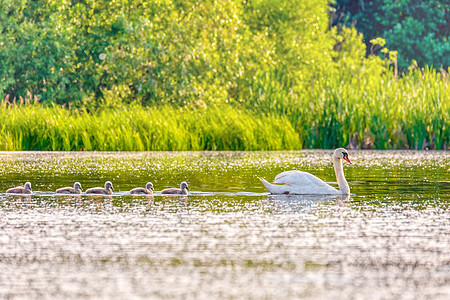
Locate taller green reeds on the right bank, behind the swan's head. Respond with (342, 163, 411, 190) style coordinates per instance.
(244, 65, 450, 149)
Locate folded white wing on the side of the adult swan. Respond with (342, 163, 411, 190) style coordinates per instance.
(274, 170, 340, 194)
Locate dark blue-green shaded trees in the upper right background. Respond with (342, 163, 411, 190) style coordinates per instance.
(331, 0, 450, 72)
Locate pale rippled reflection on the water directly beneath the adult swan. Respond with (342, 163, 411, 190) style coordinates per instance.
(266, 194, 351, 213)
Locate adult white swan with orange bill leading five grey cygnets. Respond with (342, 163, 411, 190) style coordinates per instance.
(259, 148, 351, 195)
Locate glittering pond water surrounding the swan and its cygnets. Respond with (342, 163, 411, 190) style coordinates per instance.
(0, 151, 450, 299)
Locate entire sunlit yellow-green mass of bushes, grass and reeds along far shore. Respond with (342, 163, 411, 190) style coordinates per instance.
(0, 0, 450, 151)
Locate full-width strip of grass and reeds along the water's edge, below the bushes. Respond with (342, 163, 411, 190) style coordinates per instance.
(0, 68, 450, 151)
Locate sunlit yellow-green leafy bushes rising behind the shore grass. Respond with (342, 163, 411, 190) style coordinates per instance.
(0, 0, 383, 105)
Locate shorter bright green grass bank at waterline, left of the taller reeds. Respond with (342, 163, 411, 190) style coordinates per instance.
(0, 104, 301, 151)
